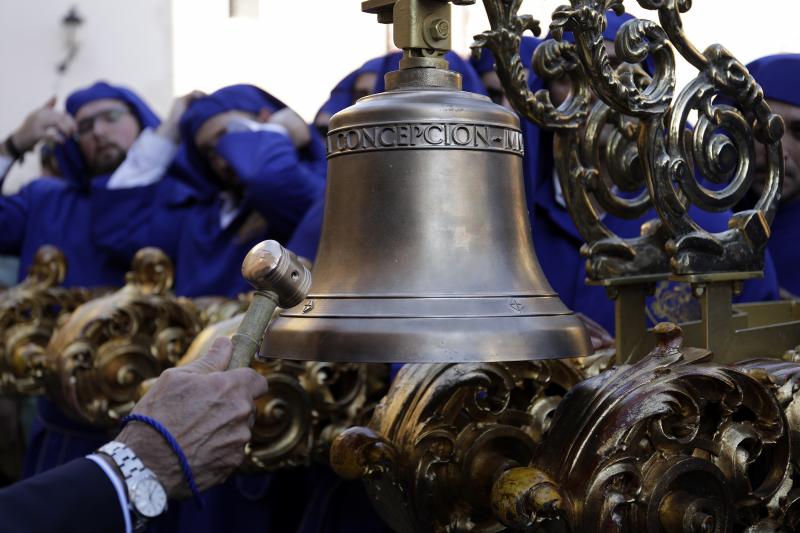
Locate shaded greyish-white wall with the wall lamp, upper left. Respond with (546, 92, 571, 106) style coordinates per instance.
(0, 0, 173, 193)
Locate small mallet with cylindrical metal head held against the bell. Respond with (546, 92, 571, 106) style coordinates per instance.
(228, 241, 311, 370)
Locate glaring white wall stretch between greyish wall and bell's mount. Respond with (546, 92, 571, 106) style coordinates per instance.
(173, 0, 387, 121)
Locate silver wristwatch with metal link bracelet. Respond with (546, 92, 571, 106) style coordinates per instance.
(97, 441, 167, 533)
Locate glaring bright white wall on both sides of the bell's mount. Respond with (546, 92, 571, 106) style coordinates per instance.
(173, 0, 800, 120)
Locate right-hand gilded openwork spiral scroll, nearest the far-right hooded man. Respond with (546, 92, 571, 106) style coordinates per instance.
(639, 45, 783, 275)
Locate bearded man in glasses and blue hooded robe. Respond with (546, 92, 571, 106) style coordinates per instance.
(0, 82, 166, 287)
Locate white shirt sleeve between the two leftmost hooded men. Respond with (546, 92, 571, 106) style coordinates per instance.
(106, 128, 178, 189)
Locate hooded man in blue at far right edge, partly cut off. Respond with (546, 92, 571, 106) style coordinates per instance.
(747, 54, 800, 299)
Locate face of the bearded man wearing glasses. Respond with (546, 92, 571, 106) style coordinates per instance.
(75, 98, 141, 176)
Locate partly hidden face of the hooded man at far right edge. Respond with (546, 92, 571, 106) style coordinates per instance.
(756, 100, 800, 203)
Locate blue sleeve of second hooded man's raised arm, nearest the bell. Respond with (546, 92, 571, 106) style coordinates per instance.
(217, 131, 325, 241)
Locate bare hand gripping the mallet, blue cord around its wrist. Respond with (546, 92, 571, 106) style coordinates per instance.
(115, 338, 267, 498)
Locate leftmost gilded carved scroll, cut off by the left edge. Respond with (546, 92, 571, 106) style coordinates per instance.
(0, 246, 93, 394)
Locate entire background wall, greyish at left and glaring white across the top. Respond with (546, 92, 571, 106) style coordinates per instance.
(0, 0, 800, 191)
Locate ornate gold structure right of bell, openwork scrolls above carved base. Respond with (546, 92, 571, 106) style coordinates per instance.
(331, 0, 800, 532)
